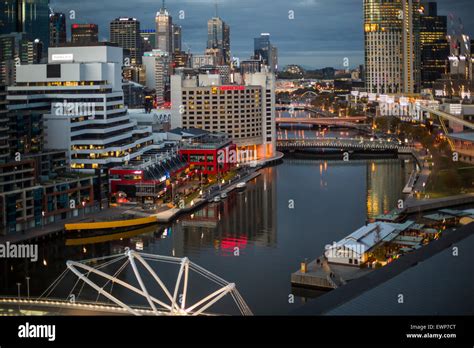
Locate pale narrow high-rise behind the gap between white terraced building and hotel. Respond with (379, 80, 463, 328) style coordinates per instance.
(143, 50, 171, 104)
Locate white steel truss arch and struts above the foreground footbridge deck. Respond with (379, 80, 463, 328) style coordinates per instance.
(42, 249, 252, 316)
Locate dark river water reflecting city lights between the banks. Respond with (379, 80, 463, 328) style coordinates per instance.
(0, 159, 411, 314)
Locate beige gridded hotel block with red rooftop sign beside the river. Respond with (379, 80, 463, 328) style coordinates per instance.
(171, 72, 276, 160)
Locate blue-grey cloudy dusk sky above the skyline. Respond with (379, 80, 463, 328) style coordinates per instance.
(51, 0, 474, 68)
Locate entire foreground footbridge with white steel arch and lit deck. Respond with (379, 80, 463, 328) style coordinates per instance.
(0, 249, 252, 316)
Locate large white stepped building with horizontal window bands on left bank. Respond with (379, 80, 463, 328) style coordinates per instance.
(8, 43, 153, 173)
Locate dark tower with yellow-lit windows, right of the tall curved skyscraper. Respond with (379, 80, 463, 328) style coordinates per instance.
(420, 2, 449, 88)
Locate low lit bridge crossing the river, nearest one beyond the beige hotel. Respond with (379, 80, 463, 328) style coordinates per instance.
(277, 138, 403, 152)
